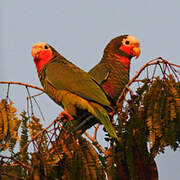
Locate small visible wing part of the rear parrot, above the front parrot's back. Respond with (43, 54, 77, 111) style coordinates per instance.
(88, 63, 110, 85)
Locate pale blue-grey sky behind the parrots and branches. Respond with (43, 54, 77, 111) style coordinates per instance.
(0, 0, 180, 180)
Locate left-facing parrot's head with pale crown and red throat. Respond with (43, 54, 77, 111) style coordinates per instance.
(31, 42, 57, 75)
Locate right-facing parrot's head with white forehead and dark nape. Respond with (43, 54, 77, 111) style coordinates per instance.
(104, 35, 141, 70)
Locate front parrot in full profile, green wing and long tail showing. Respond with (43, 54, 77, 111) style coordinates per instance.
(32, 42, 118, 139)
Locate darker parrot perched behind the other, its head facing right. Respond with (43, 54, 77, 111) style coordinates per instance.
(89, 35, 140, 104)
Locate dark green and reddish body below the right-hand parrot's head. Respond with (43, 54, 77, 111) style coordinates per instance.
(89, 56, 129, 104)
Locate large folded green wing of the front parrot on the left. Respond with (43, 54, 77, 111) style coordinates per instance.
(45, 57, 110, 106)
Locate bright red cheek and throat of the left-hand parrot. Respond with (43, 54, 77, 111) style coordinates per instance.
(34, 50, 53, 76)
